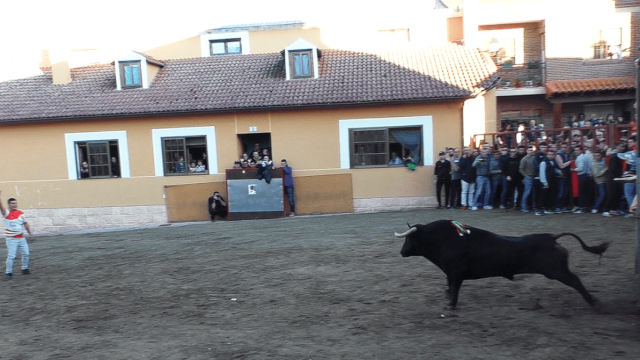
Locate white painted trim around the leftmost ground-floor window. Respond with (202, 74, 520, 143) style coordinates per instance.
(64, 131, 131, 180)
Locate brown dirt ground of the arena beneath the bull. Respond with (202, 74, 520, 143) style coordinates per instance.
(0, 209, 640, 360)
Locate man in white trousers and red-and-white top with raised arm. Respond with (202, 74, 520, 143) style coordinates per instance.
(0, 190, 33, 280)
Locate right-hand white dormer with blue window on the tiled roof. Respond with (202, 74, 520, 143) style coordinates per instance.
(282, 38, 320, 80)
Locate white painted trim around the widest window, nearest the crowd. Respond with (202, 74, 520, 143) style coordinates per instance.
(338, 116, 434, 169)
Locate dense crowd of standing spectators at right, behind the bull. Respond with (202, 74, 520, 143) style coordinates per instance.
(434, 122, 638, 217)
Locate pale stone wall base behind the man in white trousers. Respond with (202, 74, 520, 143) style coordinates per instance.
(0, 205, 167, 236)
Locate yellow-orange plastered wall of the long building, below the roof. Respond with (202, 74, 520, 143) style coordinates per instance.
(0, 101, 462, 209)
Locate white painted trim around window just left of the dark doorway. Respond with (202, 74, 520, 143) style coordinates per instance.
(151, 126, 218, 176)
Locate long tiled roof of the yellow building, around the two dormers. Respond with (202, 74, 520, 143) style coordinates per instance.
(0, 44, 496, 123)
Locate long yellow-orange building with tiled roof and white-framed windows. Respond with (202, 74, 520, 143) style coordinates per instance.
(0, 39, 497, 233)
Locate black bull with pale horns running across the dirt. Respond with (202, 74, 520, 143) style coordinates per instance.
(395, 220, 609, 309)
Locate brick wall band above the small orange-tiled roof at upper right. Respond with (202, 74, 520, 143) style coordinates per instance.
(546, 57, 635, 81)
